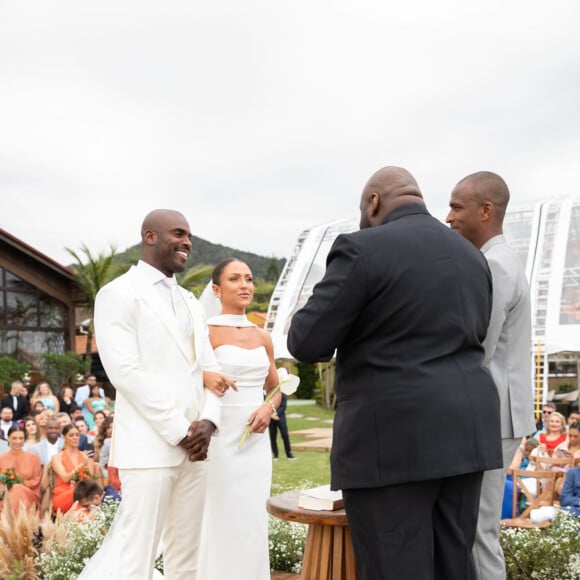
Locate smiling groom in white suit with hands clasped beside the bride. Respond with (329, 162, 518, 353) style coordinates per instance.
(89, 210, 234, 580)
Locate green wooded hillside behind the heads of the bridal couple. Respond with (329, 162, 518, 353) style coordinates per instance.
(115, 236, 286, 282)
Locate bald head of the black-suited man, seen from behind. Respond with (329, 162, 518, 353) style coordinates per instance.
(360, 167, 425, 229)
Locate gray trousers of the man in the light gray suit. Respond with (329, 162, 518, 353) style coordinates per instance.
(473, 437, 522, 580)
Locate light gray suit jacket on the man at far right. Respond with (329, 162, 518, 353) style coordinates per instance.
(481, 235, 535, 439)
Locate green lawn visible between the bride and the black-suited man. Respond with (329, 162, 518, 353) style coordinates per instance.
(272, 405, 334, 495)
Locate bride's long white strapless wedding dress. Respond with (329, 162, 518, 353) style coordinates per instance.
(199, 344, 272, 580)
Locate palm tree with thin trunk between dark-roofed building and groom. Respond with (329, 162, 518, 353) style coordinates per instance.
(65, 244, 120, 375)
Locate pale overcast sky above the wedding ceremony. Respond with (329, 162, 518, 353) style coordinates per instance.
(0, 0, 580, 264)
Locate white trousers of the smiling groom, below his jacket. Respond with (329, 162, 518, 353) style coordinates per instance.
(80, 458, 207, 580)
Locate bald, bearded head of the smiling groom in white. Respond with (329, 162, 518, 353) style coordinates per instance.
(141, 209, 191, 277)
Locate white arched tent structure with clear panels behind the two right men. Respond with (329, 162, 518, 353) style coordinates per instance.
(266, 196, 580, 358)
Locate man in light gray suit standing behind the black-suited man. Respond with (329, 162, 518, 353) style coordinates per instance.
(447, 171, 535, 580)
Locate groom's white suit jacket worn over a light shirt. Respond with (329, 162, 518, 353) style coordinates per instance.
(94, 262, 220, 468)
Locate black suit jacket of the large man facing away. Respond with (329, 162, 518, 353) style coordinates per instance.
(288, 204, 502, 489)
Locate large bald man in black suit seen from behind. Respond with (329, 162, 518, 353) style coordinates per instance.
(288, 167, 502, 580)
